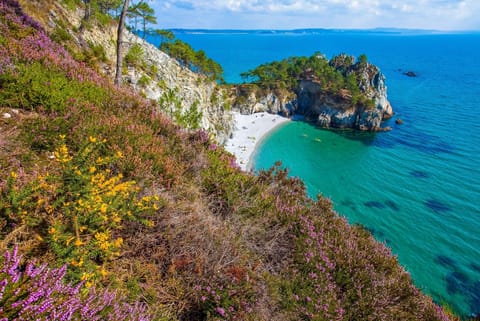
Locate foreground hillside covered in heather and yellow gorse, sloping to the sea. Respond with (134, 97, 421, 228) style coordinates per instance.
(0, 0, 462, 320)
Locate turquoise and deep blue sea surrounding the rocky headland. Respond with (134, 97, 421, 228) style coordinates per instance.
(145, 31, 480, 316)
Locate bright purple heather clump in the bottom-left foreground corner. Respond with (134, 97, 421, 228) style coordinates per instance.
(0, 248, 150, 321)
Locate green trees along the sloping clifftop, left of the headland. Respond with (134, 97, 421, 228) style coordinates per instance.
(160, 39, 224, 82)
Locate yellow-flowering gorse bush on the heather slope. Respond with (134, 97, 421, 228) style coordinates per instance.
(0, 135, 160, 282)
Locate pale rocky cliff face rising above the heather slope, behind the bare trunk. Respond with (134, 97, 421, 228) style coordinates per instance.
(20, 0, 233, 143)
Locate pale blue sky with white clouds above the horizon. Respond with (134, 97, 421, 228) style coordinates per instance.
(150, 0, 480, 30)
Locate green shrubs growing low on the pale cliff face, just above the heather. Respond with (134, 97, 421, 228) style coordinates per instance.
(159, 89, 203, 129)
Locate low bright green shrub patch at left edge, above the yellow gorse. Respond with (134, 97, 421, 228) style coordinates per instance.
(0, 62, 107, 111)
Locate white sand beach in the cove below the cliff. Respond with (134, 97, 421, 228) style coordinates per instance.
(225, 112, 289, 171)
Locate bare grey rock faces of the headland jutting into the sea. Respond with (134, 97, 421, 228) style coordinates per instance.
(233, 55, 393, 131)
